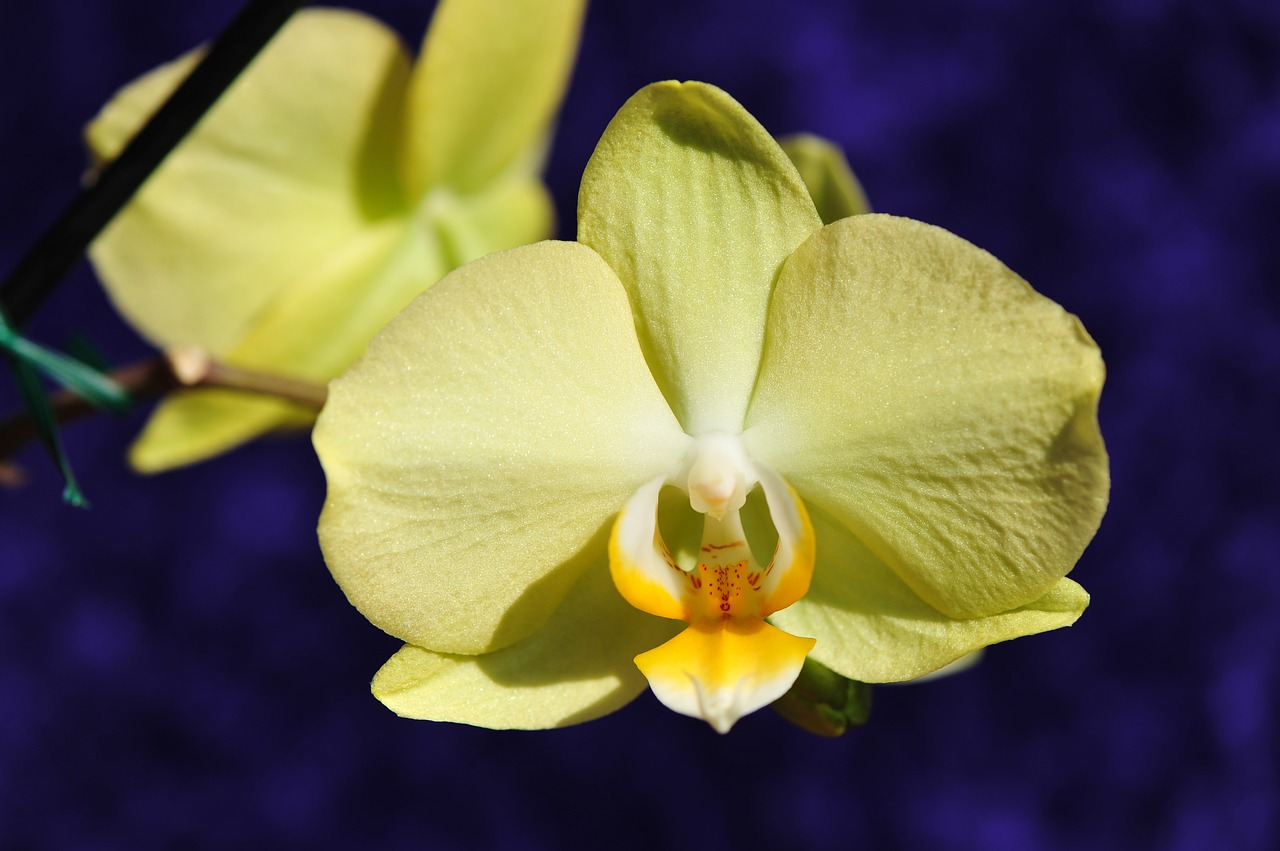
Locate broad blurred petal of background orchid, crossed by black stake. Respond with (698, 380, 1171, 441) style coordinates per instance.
(88, 10, 408, 356)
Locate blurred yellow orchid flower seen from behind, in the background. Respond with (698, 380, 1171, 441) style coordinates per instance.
(87, 0, 585, 471)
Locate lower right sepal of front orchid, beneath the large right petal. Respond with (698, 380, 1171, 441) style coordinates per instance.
(769, 511, 1089, 682)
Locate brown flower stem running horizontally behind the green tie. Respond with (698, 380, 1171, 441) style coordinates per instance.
(0, 347, 329, 478)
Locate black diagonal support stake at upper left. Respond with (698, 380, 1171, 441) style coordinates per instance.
(0, 0, 306, 326)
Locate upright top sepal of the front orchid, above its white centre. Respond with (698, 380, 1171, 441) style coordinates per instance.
(577, 82, 822, 435)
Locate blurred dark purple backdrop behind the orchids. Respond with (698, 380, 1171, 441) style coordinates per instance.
(0, 0, 1280, 851)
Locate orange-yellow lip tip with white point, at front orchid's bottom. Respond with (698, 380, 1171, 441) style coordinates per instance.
(636, 618, 814, 733)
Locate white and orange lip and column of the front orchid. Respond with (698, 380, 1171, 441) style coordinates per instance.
(609, 433, 814, 732)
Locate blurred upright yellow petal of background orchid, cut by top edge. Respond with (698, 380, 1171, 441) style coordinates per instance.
(402, 0, 586, 195)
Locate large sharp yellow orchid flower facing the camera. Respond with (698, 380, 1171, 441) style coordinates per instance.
(314, 82, 1108, 731)
